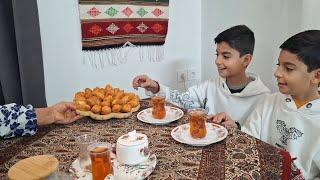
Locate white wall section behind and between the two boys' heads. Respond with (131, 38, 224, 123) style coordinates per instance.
(202, 0, 301, 91)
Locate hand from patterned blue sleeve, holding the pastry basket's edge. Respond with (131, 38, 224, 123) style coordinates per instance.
(35, 102, 81, 126)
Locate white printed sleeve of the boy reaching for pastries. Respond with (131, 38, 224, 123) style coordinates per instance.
(146, 84, 206, 109)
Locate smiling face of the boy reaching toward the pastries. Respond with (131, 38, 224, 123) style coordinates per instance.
(215, 42, 251, 78)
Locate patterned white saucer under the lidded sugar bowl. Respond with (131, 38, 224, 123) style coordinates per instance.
(69, 153, 157, 180)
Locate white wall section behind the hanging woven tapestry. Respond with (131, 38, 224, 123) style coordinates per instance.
(37, 0, 202, 105)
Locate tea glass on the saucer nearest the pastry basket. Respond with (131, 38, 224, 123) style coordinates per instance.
(151, 93, 166, 119)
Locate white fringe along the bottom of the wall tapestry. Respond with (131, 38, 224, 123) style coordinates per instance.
(82, 46, 164, 68)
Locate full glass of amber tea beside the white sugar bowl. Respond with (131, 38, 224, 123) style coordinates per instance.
(88, 142, 113, 180)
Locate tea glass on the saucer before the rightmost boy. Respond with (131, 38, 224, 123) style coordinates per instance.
(188, 108, 207, 139)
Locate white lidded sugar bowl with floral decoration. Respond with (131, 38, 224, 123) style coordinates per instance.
(116, 130, 150, 165)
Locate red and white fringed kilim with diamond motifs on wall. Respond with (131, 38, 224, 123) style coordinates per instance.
(79, 0, 169, 66)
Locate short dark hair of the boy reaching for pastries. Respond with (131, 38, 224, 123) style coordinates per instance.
(214, 25, 255, 57)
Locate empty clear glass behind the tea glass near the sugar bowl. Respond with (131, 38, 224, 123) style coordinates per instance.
(75, 134, 98, 172)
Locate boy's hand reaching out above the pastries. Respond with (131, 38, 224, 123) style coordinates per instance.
(132, 75, 159, 94)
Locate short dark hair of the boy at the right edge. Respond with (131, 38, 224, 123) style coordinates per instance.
(280, 30, 320, 72)
